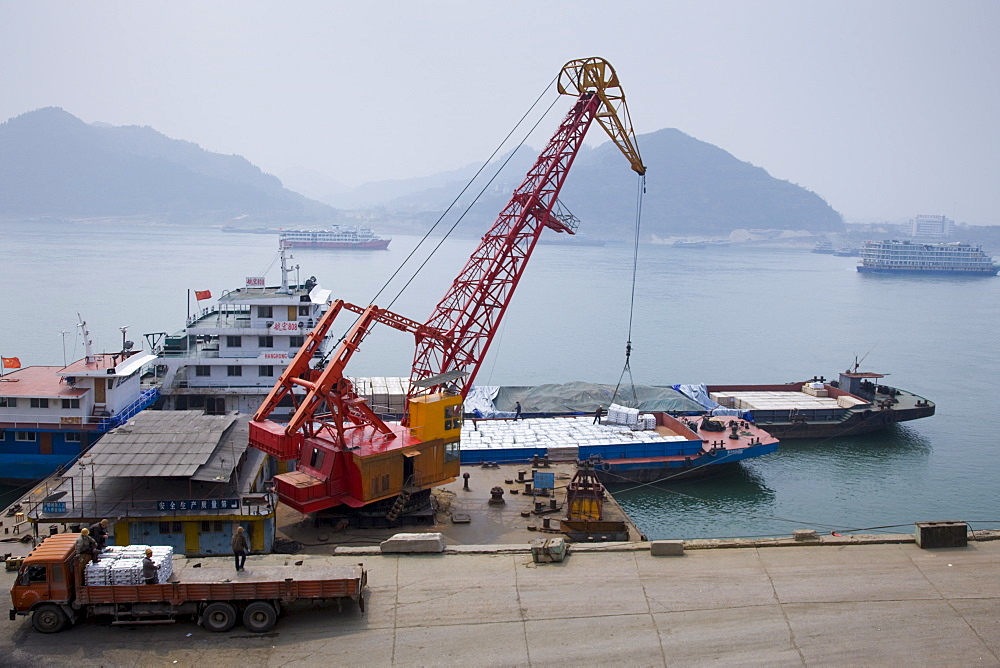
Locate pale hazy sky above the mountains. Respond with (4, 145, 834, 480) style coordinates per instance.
(0, 0, 1000, 225)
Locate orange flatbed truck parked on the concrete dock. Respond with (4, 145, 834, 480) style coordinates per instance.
(10, 533, 368, 633)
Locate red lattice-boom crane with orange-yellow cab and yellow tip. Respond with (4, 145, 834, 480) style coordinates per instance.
(250, 58, 645, 521)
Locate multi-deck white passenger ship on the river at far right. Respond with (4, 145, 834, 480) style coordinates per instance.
(858, 239, 1000, 276)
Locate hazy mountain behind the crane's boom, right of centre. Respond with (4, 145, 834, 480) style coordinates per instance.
(340, 128, 844, 239)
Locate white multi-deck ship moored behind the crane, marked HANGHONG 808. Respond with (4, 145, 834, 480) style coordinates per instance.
(147, 243, 330, 415)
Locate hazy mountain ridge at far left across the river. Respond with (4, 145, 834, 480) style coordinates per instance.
(0, 107, 337, 222)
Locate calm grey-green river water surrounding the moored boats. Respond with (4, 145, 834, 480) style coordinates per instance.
(0, 223, 1000, 538)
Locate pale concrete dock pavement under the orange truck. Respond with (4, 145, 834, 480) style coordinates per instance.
(0, 541, 1000, 668)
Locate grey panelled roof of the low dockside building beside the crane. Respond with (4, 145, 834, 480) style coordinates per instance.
(73, 411, 248, 481)
